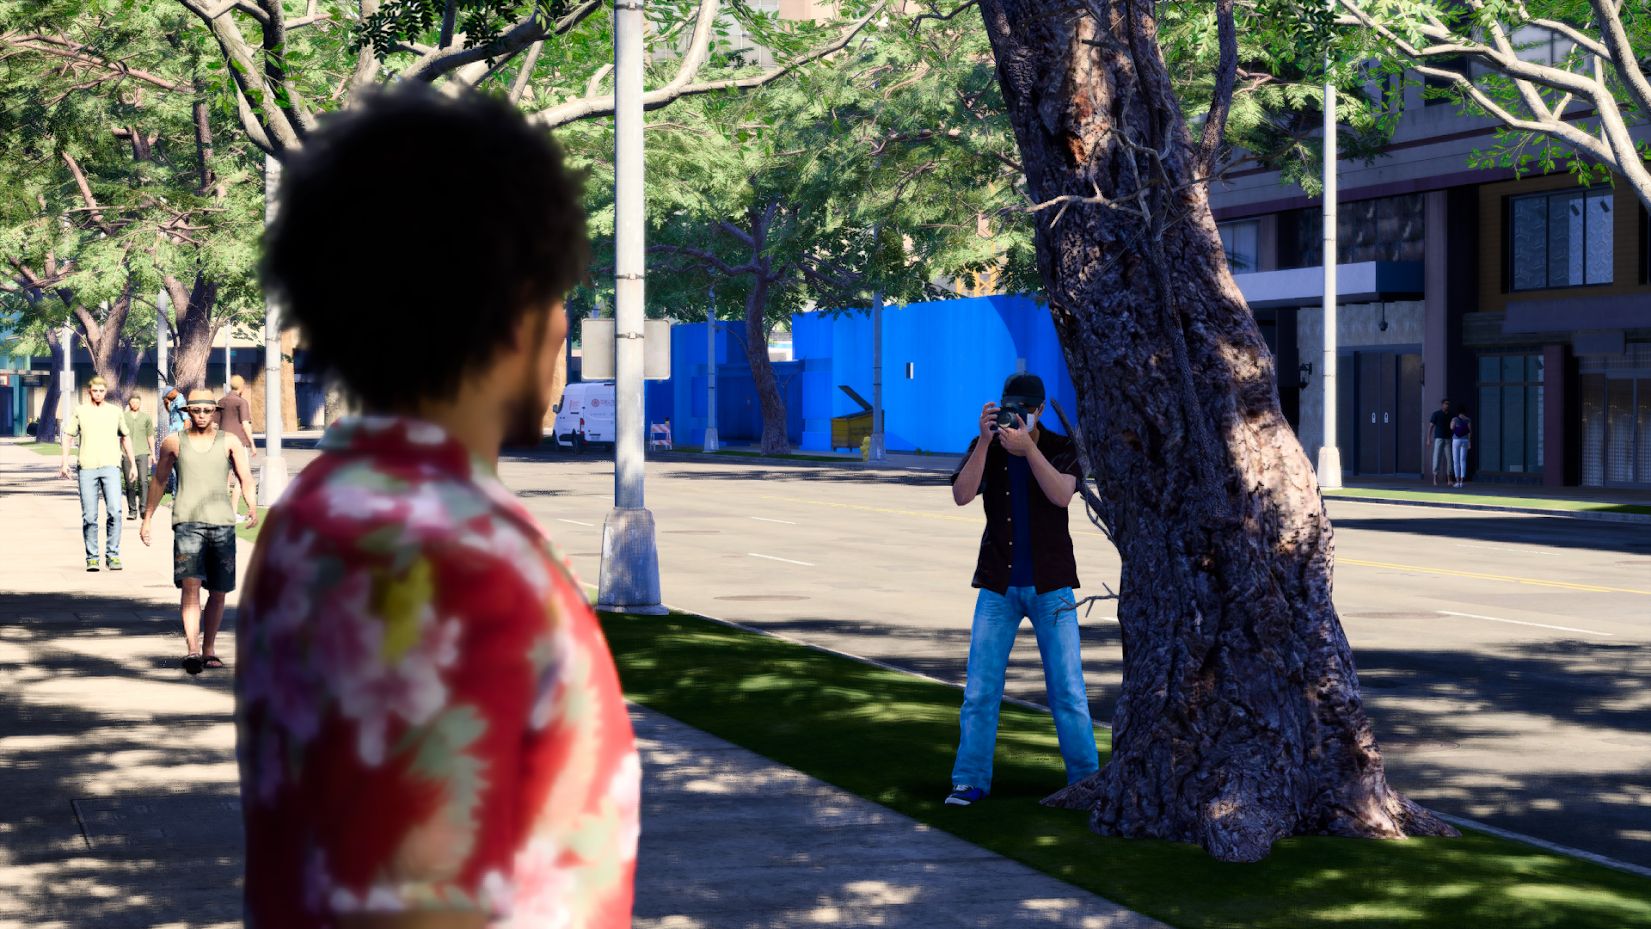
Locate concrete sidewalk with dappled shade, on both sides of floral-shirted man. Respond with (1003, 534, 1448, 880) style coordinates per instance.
(0, 441, 1159, 929)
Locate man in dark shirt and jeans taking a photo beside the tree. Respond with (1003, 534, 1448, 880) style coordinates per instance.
(946, 375, 1100, 807)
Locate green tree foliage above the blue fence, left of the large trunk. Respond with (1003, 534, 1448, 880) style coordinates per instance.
(587, 7, 1032, 334)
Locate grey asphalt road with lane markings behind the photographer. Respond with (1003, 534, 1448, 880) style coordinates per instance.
(277, 452, 1651, 866)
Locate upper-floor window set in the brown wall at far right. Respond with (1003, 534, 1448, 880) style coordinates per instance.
(1507, 188, 1613, 290)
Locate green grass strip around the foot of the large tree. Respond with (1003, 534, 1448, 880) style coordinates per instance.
(601, 614, 1651, 929)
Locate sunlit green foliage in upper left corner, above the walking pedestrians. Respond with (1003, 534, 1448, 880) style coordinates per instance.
(0, 0, 263, 347)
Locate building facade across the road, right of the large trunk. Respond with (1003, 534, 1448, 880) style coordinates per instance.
(1210, 77, 1651, 487)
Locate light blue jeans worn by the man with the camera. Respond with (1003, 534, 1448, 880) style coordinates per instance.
(951, 587, 1101, 790)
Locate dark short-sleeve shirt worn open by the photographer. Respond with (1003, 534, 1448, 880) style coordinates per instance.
(951, 429, 1083, 594)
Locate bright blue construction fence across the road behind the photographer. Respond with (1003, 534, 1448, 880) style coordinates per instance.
(647, 295, 1076, 454)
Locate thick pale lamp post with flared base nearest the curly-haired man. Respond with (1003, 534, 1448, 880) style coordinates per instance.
(596, 0, 665, 614)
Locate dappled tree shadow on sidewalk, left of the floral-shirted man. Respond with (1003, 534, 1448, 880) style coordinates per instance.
(0, 594, 243, 929)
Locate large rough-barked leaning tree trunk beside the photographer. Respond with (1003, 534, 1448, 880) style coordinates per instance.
(981, 0, 1453, 861)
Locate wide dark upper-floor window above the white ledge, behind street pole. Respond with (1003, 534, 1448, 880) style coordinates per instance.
(1280, 193, 1425, 267)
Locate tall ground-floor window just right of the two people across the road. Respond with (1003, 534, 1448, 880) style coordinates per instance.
(1468, 355, 1545, 474)
